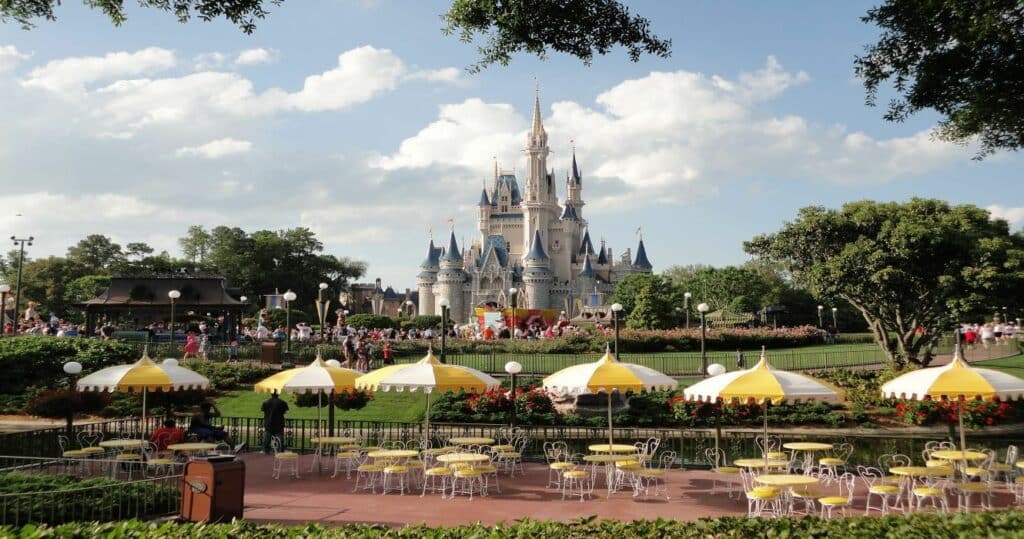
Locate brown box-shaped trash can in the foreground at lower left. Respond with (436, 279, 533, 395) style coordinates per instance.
(181, 457, 246, 523)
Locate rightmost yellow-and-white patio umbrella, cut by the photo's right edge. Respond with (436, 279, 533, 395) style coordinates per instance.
(882, 343, 1024, 477)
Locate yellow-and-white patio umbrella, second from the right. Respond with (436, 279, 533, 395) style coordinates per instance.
(683, 346, 839, 467)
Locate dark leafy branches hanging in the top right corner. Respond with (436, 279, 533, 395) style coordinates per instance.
(855, 0, 1024, 159)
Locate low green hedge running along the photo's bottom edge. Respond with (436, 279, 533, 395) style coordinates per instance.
(9, 510, 1024, 539)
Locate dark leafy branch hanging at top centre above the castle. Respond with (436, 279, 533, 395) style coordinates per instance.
(443, 0, 672, 72)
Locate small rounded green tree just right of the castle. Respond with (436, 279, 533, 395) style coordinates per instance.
(611, 274, 682, 327)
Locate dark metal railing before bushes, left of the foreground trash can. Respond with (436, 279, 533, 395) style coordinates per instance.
(0, 456, 181, 527)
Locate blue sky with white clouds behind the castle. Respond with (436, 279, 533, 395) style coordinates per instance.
(0, 0, 1024, 293)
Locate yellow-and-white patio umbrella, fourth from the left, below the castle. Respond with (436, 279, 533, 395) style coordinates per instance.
(544, 347, 679, 449)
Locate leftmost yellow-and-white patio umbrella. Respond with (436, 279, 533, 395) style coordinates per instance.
(76, 351, 210, 441)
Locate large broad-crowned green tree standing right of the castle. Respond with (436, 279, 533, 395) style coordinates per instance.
(743, 199, 1024, 366)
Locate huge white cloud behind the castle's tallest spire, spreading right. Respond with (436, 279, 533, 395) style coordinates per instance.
(369, 56, 969, 208)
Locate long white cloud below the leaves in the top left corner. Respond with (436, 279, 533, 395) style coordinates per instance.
(22, 47, 176, 93)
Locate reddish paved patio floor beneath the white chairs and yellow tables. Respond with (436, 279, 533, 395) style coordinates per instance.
(235, 454, 1013, 526)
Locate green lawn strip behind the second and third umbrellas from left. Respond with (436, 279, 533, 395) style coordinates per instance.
(217, 391, 425, 422)
